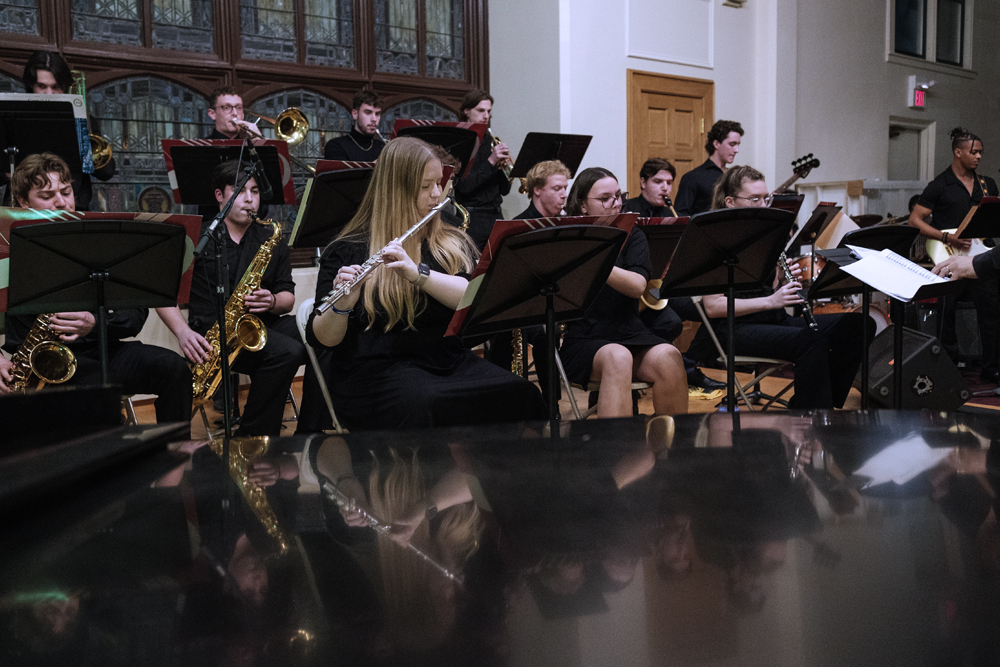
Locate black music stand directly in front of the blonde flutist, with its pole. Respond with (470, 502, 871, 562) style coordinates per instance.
(459, 225, 628, 422)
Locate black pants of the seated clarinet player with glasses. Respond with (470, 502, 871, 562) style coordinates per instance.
(716, 313, 875, 410)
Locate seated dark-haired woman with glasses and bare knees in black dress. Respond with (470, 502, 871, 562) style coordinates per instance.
(559, 167, 688, 417)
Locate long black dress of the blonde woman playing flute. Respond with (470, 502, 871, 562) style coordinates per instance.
(308, 241, 546, 429)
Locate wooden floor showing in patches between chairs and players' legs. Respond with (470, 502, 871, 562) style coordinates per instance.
(135, 369, 876, 439)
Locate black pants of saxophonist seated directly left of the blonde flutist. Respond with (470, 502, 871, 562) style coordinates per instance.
(233, 315, 306, 436)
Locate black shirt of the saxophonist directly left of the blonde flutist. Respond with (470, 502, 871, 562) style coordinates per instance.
(188, 222, 295, 336)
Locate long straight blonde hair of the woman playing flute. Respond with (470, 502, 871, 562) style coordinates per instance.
(337, 137, 478, 331)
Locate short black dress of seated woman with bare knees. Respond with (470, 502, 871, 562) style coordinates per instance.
(559, 229, 667, 384)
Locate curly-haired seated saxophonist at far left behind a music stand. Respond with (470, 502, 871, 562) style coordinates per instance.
(0, 153, 191, 422)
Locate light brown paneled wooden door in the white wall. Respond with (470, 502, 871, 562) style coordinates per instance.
(628, 70, 715, 197)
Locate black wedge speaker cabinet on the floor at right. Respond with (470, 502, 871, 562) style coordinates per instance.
(855, 327, 970, 410)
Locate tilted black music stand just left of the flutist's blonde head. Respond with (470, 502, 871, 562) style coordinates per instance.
(289, 167, 373, 248)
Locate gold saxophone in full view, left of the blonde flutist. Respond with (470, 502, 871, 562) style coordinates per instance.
(191, 220, 281, 405)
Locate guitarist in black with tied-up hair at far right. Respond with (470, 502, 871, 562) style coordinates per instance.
(909, 127, 1000, 383)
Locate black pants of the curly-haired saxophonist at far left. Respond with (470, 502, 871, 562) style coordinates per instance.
(68, 341, 192, 430)
